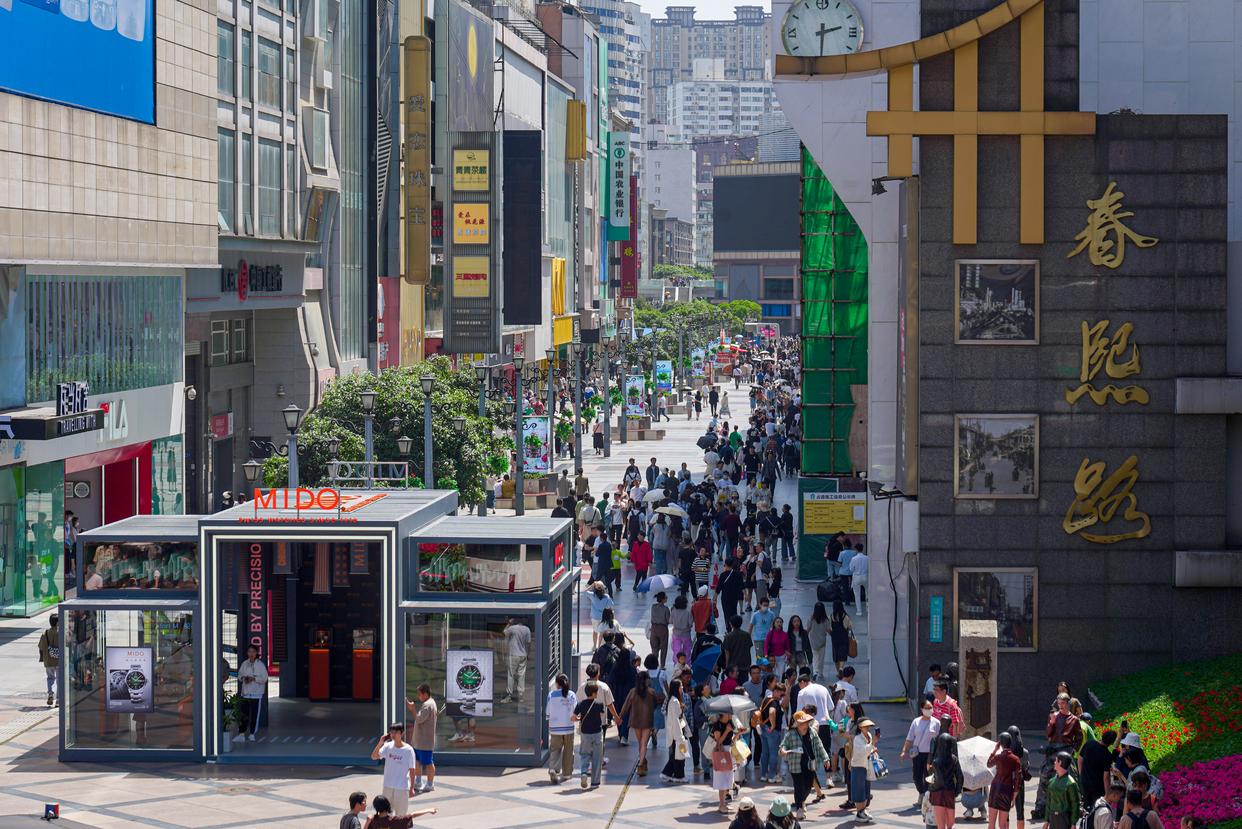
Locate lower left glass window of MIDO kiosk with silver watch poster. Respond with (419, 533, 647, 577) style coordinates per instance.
(63, 610, 194, 749)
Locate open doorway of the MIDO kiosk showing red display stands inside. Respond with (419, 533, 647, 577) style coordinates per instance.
(219, 542, 386, 763)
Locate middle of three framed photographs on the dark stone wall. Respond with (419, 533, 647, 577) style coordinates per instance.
(953, 414, 1040, 498)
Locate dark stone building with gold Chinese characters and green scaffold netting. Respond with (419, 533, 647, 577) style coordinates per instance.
(773, 0, 1242, 722)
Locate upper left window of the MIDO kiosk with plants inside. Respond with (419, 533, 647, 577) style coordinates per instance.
(82, 541, 199, 592)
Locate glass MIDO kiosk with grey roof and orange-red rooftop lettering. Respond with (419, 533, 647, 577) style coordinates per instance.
(60, 490, 578, 764)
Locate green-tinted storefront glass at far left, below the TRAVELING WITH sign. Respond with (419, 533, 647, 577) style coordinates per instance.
(0, 461, 66, 616)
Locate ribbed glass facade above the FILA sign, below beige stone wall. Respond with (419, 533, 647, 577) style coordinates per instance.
(26, 273, 185, 403)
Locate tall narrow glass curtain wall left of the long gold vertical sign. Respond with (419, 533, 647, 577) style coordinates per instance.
(337, 0, 369, 359)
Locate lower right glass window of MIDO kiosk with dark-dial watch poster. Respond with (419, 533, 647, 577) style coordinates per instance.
(405, 613, 546, 754)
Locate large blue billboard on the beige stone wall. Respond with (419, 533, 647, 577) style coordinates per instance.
(0, 0, 155, 123)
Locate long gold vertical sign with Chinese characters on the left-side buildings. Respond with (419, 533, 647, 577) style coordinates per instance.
(405, 36, 431, 285)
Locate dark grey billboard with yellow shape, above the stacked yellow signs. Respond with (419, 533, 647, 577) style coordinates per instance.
(448, 0, 496, 131)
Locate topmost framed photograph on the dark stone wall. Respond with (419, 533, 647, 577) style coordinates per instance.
(954, 259, 1040, 346)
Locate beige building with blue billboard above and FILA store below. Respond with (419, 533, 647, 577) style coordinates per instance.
(0, 0, 217, 615)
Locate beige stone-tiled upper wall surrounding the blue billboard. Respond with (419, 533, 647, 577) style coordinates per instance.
(0, 0, 216, 265)
